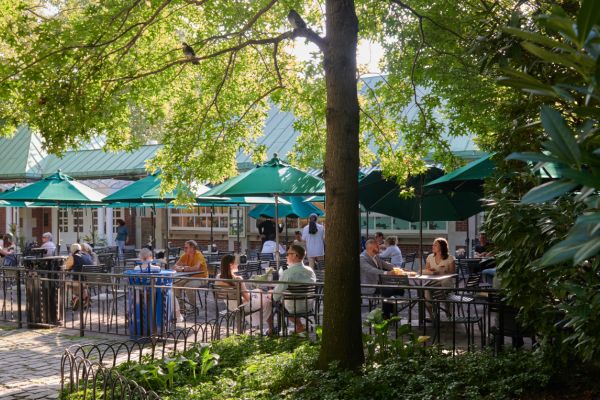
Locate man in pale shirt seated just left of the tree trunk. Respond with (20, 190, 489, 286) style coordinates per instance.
(272, 244, 317, 333)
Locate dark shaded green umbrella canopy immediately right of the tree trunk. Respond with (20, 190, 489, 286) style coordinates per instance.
(358, 168, 482, 222)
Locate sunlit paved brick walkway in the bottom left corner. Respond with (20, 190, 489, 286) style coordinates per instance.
(0, 323, 115, 400)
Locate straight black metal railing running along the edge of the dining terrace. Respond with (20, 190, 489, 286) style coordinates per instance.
(0, 267, 528, 350)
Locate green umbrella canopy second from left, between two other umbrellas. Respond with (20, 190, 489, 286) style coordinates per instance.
(104, 172, 208, 203)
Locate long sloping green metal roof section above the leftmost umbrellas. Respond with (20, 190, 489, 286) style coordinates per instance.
(42, 145, 162, 179)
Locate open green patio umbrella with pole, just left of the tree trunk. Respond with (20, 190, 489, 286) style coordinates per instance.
(204, 154, 325, 263)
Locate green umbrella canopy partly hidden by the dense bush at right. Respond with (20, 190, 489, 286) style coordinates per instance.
(425, 154, 496, 191)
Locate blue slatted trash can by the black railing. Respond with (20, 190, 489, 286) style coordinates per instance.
(125, 270, 175, 339)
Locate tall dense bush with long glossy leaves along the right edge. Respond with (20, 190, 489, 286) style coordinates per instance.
(486, 1, 600, 363)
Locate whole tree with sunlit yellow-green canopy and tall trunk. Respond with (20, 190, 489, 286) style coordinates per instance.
(0, 0, 579, 365)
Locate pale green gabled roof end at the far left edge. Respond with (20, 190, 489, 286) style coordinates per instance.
(0, 125, 45, 181)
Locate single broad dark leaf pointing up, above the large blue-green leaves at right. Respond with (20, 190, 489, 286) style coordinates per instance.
(540, 105, 581, 167)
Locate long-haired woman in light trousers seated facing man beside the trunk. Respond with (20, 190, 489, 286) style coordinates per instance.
(215, 255, 273, 333)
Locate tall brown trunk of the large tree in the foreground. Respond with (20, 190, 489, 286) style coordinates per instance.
(319, 0, 364, 369)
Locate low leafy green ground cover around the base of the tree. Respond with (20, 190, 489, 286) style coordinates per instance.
(92, 334, 551, 400)
